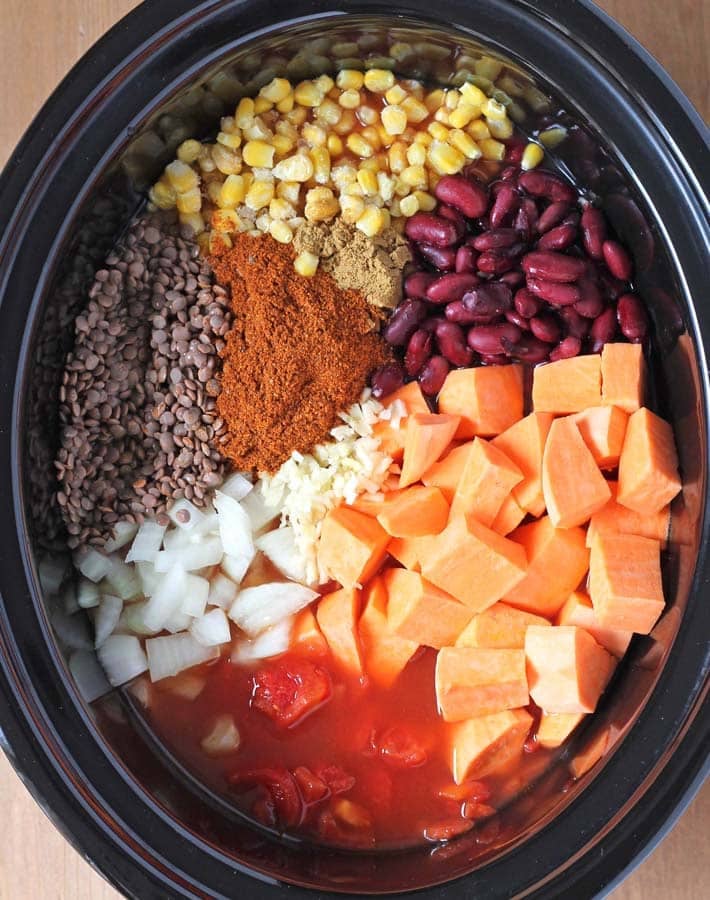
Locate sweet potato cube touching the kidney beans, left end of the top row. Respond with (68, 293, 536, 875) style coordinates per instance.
(439, 366, 523, 438)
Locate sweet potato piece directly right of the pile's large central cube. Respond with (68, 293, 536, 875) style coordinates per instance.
(505, 516, 589, 618)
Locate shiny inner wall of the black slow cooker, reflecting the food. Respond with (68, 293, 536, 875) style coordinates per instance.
(4, 7, 707, 896)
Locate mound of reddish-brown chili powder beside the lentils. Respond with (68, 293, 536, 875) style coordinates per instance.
(210, 234, 390, 472)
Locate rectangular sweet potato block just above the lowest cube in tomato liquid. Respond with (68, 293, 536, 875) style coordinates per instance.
(434, 647, 528, 722)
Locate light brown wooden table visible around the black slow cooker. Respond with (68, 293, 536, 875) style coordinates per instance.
(0, 0, 710, 900)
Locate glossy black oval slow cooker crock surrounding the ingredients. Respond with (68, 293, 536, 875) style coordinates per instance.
(0, 0, 710, 900)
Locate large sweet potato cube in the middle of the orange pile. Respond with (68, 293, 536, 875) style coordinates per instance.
(419, 516, 527, 612)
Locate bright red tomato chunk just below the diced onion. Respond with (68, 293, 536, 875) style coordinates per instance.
(251, 657, 332, 728)
